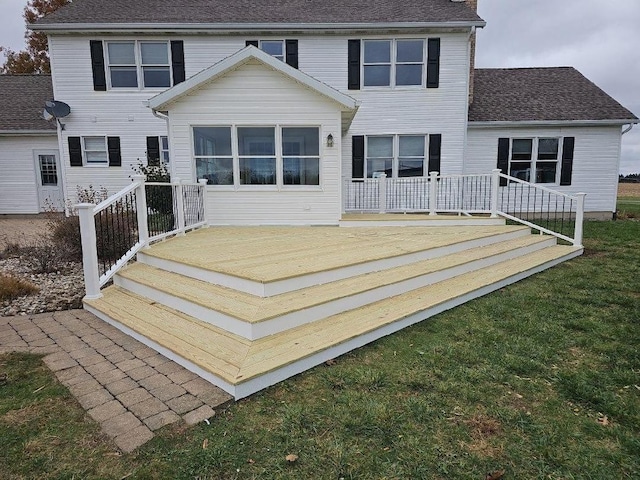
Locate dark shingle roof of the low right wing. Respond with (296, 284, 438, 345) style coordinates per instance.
(469, 67, 637, 122)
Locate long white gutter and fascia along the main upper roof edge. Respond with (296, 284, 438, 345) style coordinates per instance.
(27, 20, 487, 33)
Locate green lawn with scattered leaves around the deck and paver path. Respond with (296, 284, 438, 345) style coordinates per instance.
(0, 220, 640, 480)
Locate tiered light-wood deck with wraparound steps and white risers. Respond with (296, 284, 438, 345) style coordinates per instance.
(85, 216, 582, 398)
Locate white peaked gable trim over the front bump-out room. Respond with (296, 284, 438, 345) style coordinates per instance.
(147, 45, 358, 111)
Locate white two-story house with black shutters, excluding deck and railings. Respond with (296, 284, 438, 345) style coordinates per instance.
(0, 0, 638, 224)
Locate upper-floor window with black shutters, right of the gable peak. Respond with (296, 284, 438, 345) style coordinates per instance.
(362, 39, 425, 87)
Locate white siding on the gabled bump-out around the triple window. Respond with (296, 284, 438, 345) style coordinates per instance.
(168, 61, 341, 225)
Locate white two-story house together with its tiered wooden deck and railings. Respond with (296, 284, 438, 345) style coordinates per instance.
(3, 0, 638, 398)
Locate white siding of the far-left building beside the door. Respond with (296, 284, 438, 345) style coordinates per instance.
(0, 135, 58, 215)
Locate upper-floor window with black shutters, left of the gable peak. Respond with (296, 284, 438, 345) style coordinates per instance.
(106, 41, 171, 89)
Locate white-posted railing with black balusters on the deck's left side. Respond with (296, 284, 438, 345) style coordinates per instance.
(75, 175, 206, 299)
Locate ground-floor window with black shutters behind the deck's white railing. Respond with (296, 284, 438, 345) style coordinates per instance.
(365, 135, 427, 178)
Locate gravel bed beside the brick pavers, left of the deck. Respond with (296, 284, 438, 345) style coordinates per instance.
(0, 257, 84, 316)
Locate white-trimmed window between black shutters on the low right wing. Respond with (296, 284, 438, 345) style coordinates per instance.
(509, 137, 561, 183)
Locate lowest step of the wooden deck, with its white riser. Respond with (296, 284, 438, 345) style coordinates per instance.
(85, 245, 582, 398)
